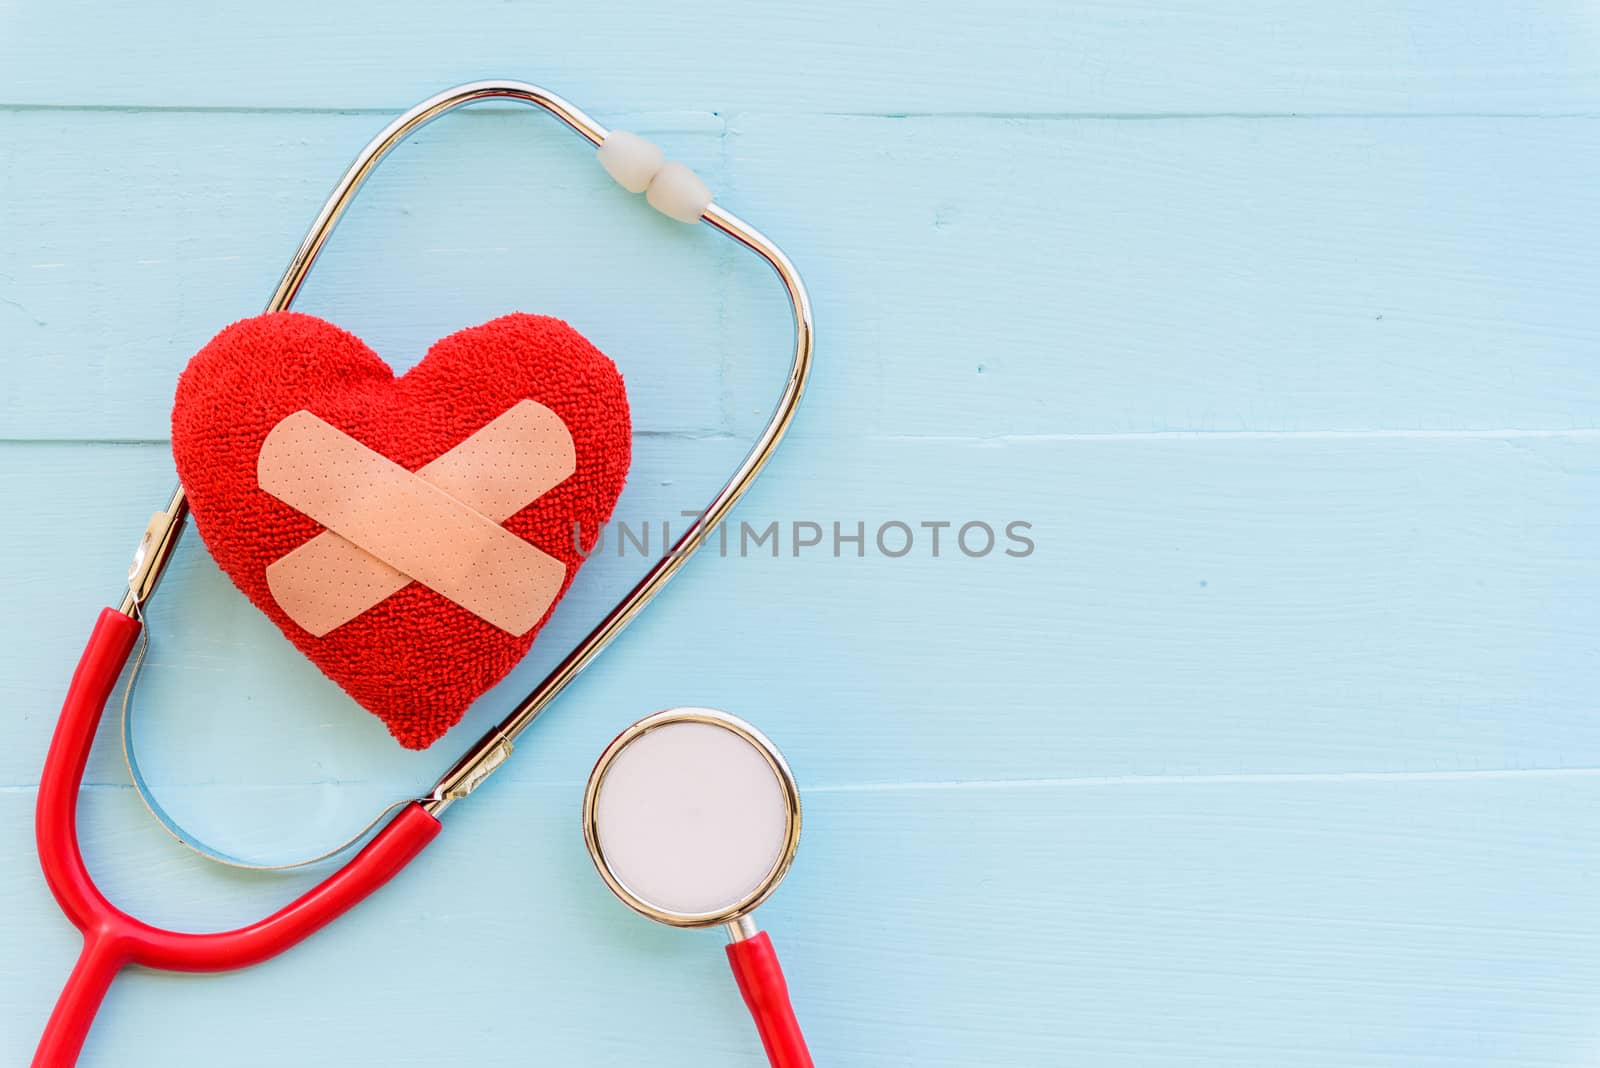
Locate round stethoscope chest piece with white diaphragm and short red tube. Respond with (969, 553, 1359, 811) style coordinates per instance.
(582, 708, 811, 1068)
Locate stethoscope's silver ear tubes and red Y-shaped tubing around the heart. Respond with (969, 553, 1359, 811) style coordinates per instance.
(34, 82, 813, 1068)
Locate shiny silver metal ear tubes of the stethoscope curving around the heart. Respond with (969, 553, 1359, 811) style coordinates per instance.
(120, 82, 813, 815)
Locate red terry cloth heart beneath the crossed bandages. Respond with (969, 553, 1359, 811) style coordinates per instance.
(173, 312, 630, 748)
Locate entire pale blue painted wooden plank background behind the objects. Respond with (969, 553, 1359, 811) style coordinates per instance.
(0, 0, 1600, 1068)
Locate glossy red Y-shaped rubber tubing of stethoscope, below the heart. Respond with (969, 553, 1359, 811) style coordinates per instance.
(34, 608, 438, 1068)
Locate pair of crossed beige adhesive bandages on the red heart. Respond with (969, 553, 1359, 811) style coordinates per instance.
(256, 401, 578, 636)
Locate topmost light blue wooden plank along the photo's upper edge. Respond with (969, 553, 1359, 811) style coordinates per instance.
(0, 0, 1600, 114)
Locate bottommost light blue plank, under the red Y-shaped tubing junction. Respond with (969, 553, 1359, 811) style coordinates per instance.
(0, 772, 1600, 1068)
